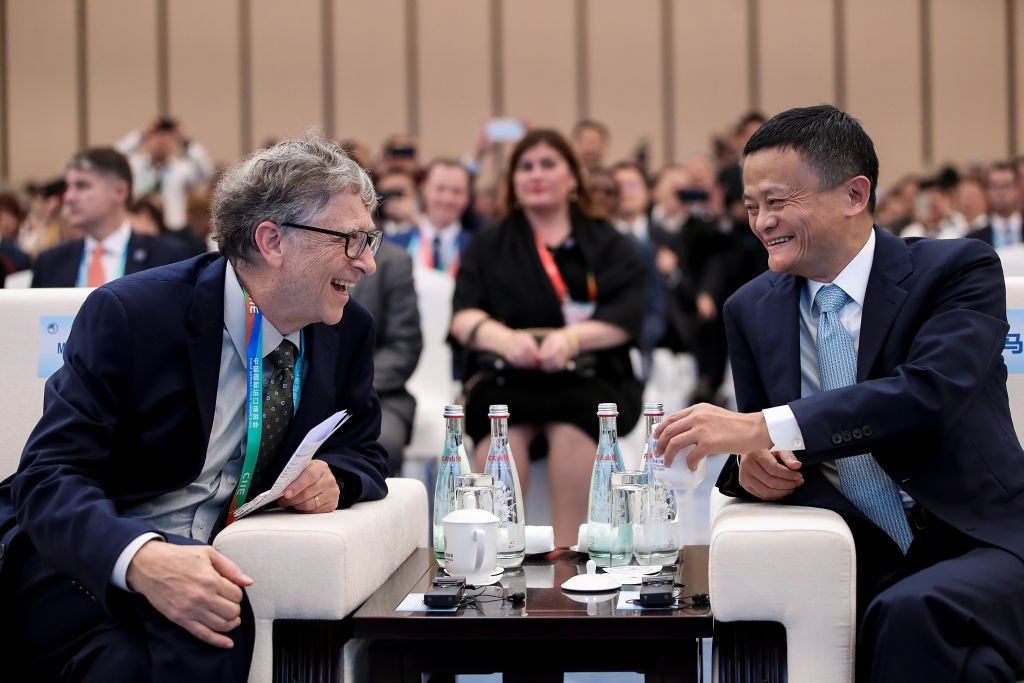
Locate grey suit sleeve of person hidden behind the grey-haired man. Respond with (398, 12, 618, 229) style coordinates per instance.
(374, 252, 423, 393)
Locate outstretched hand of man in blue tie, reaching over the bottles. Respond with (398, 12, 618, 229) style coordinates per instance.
(654, 403, 772, 471)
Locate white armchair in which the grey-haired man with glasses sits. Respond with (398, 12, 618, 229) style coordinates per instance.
(0, 289, 427, 683)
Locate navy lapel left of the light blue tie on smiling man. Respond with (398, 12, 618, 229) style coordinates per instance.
(757, 275, 804, 405)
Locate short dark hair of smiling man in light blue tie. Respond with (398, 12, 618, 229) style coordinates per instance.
(743, 104, 879, 214)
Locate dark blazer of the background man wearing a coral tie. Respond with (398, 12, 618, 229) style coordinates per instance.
(32, 232, 190, 287)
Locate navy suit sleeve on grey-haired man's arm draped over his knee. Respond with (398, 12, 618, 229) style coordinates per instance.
(11, 289, 157, 599)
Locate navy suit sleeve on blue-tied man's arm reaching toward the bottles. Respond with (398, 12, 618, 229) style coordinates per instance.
(786, 240, 1009, 463)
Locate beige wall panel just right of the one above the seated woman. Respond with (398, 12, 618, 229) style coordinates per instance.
(587, 0, 665, 168)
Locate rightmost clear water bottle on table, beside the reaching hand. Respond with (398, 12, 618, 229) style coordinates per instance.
(640, 403, 680, 564)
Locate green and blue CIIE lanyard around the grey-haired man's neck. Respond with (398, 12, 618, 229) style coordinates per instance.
(233, 290, 304, 516)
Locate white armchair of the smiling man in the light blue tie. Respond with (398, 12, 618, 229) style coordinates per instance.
(709, 278, 1024, 683)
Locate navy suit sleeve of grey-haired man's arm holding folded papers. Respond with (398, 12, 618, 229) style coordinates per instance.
(316, 314, 388, 501)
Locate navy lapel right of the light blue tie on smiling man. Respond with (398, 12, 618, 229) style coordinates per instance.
(857, 228, 913, 382)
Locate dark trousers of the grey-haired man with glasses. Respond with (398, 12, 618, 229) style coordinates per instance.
(0, 540, 254, 683)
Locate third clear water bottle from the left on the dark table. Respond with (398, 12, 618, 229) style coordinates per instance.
(587, 403, 626, 567)
